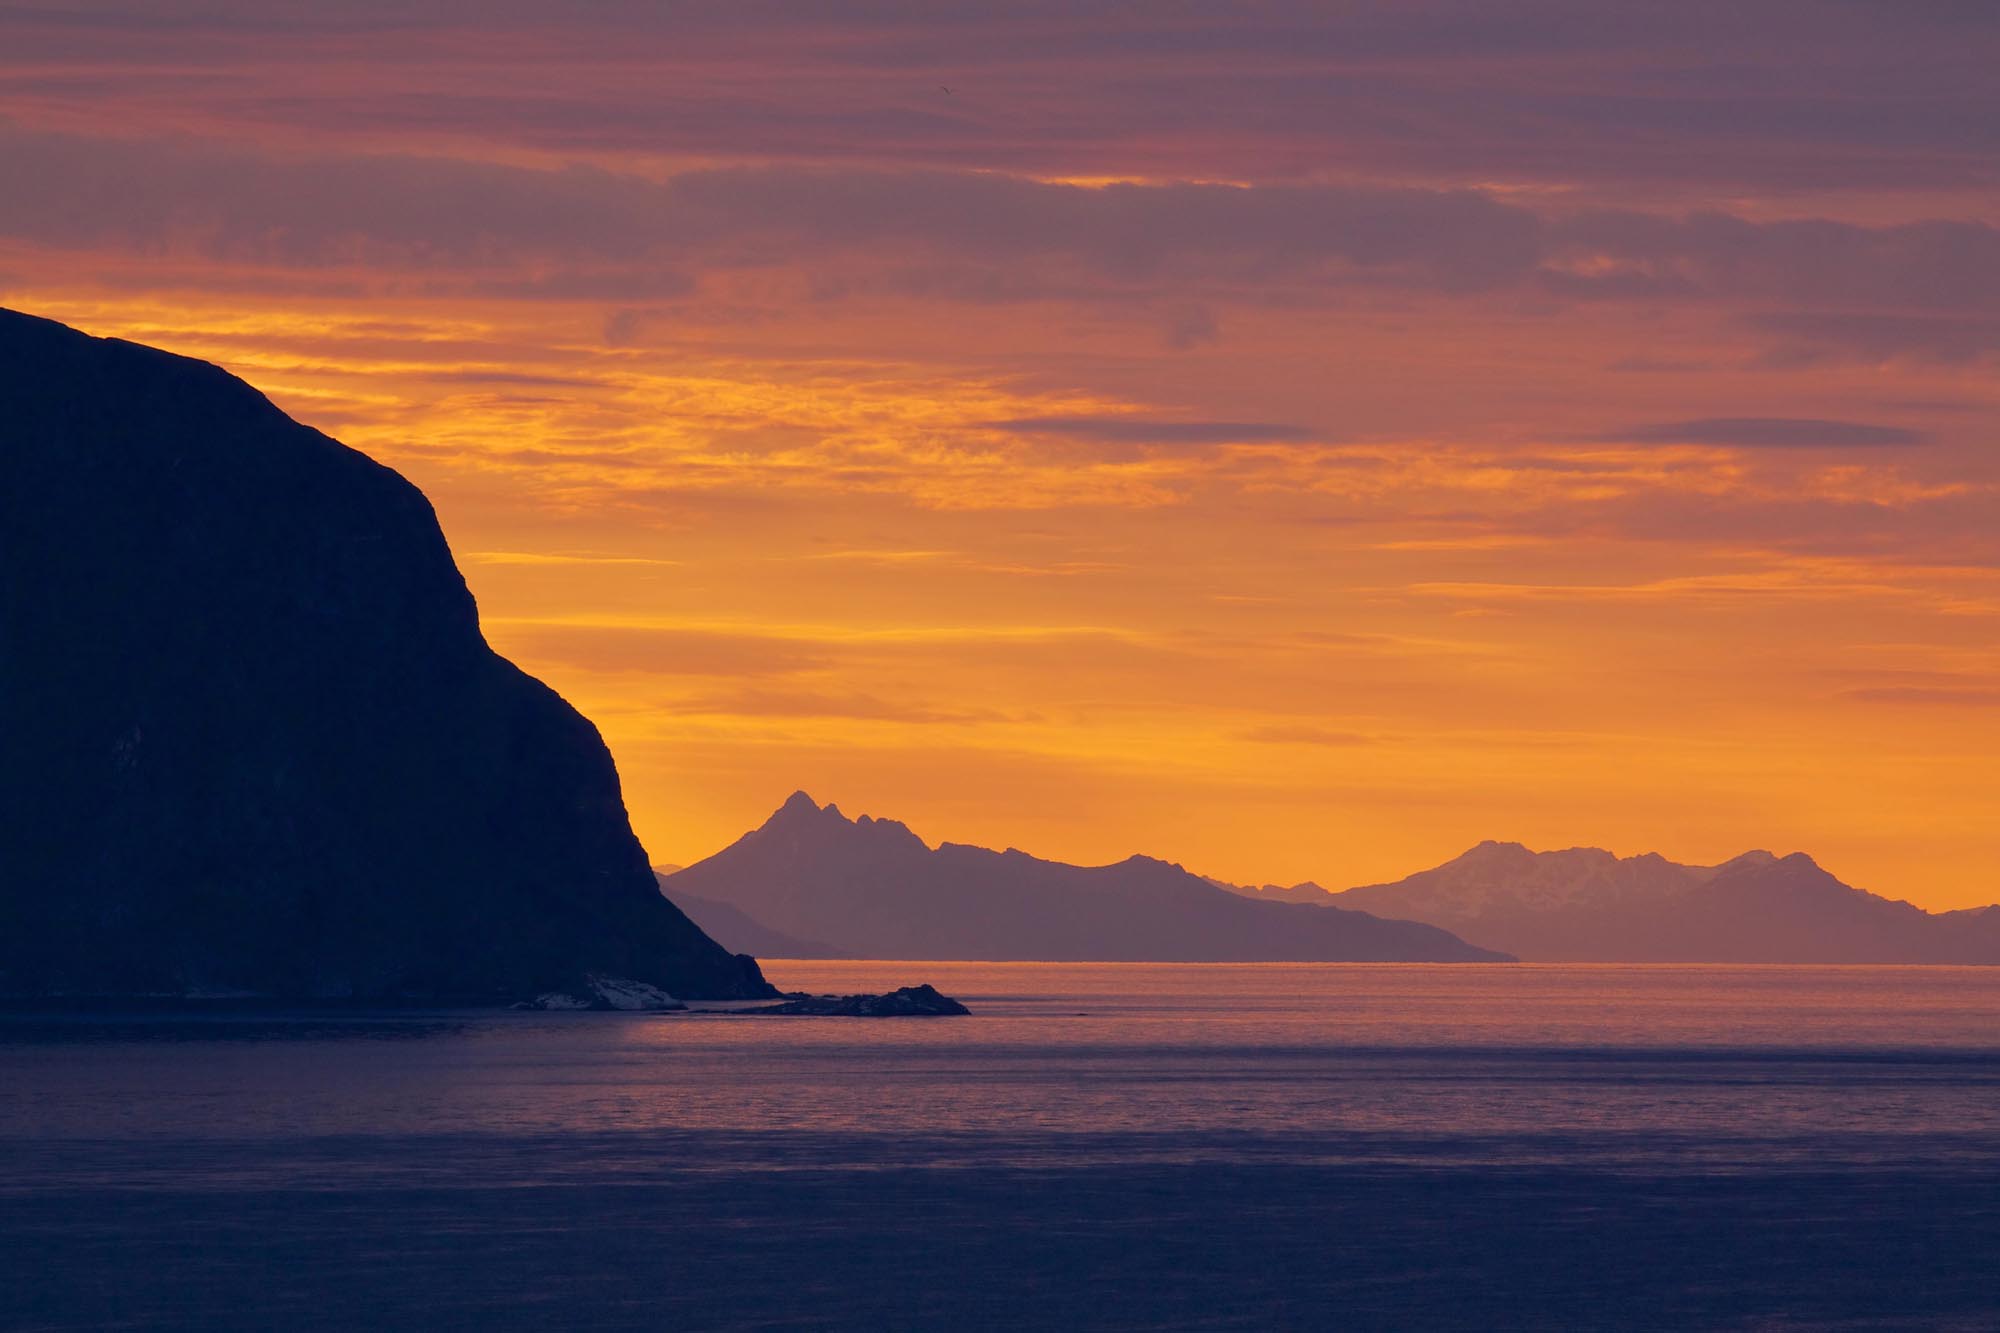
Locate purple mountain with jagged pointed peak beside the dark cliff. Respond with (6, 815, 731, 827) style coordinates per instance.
(662, 793, 1506, 963)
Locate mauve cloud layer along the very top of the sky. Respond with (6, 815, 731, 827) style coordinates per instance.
(0, 0, 2000, 192)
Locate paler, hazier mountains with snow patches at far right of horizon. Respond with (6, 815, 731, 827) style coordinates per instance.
(1230, 843, 2000, 963)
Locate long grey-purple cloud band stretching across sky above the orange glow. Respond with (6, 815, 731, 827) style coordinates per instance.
(0, 128, 2000, 324)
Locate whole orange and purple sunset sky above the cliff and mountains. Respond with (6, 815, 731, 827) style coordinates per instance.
(0, 0, 2000, 907)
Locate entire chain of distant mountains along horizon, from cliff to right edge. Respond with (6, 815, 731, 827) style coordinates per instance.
(658, 793, 2000, 965)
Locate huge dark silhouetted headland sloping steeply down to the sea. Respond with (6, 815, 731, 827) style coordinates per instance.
(0, 312, 772, 1001)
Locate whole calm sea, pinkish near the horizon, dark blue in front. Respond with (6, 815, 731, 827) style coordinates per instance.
(0, 963, 2000, 1329)
